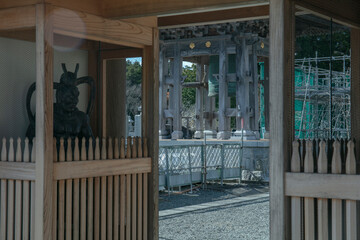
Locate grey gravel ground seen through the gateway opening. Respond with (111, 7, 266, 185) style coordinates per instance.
(159, 184, 269, 240)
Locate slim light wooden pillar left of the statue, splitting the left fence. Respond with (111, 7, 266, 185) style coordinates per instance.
(35, 4, 53, 240)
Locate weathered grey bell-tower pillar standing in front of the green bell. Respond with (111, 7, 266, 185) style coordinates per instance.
(217, 40, 230, 139)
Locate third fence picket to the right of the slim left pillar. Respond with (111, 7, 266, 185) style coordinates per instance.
(65, 138, 73, 239)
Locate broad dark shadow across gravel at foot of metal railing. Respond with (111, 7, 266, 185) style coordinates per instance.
(159, 183, 269, 211)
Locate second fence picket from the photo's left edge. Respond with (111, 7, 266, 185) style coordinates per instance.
(7, 138, 15, 239)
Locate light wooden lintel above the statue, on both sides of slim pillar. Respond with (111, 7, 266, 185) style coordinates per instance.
(0, 5, 153, 48)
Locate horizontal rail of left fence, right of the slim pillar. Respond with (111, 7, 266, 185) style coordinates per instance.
(54, 158, 151, 180)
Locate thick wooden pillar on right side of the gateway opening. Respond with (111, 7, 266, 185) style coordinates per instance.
(270, 0, 295, 240)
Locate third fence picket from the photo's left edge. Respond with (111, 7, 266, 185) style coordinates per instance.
(14, 138, 23, 240)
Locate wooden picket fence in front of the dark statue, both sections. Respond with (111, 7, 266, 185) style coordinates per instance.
(0, 138, 151, 240)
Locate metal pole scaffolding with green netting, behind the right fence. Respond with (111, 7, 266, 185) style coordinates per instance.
(295, 54, 351, 139)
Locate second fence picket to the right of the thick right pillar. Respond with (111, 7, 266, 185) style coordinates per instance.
(304, 140, 315, 240)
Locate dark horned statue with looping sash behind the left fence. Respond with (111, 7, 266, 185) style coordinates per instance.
(26, 63, 95, 140)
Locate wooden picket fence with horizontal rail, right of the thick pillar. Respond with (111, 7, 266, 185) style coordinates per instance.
(285, 140, 360, 240)
